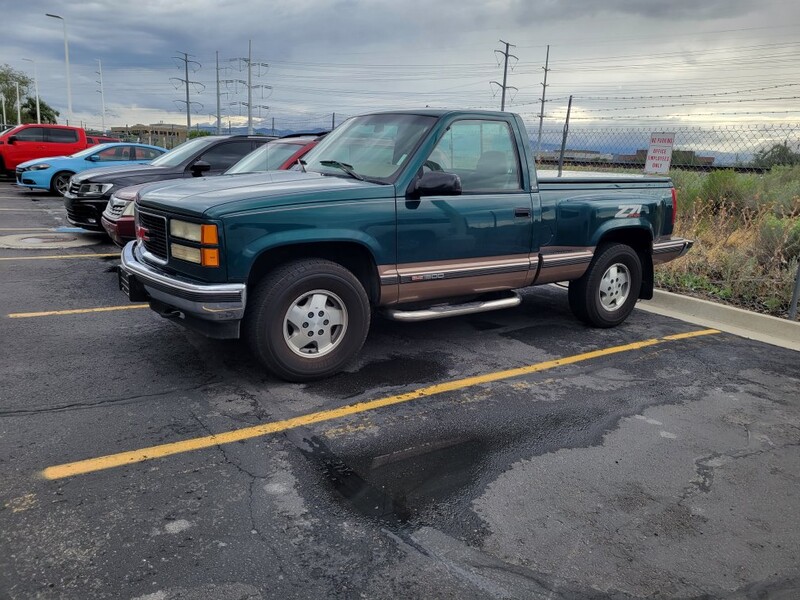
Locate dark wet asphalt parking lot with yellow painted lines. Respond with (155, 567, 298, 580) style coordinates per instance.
(0, 181, 800, 600)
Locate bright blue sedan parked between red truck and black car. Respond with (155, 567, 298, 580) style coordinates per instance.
(16, 142, 167, 196)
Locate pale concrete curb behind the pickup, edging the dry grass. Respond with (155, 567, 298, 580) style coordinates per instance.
(636, 290, 800, 351)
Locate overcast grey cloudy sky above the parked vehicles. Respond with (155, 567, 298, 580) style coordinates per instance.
(0, 0, 800, 128)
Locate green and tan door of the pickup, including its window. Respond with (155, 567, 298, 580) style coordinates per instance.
(397, 118, 536, 302)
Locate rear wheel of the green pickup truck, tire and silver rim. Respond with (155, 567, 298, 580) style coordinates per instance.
(568, 244, 642, 328)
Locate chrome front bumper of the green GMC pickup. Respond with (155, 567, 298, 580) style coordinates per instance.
(120, 241, 247, 324)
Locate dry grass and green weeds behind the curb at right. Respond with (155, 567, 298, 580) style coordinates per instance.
(656, 167, 800, 317)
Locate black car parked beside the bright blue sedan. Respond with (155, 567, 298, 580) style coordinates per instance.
(64, 135, 275, 231)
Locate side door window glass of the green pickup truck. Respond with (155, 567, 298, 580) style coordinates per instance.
(424, 121, 522, 193)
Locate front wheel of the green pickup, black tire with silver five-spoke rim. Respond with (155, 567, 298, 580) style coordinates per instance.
(243, 259, 371, 382)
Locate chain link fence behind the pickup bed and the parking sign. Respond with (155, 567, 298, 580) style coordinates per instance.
(528, 124, 800, 171)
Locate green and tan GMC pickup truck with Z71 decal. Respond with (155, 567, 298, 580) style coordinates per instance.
(120, 110, 691, 381)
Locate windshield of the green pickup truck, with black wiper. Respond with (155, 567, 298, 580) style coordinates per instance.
(305, 113, 436, 183)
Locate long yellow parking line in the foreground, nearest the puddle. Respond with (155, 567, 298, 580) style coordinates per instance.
(41, 329, 720, 479)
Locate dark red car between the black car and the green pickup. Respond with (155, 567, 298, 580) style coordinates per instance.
(100, 133, 325, 246)
